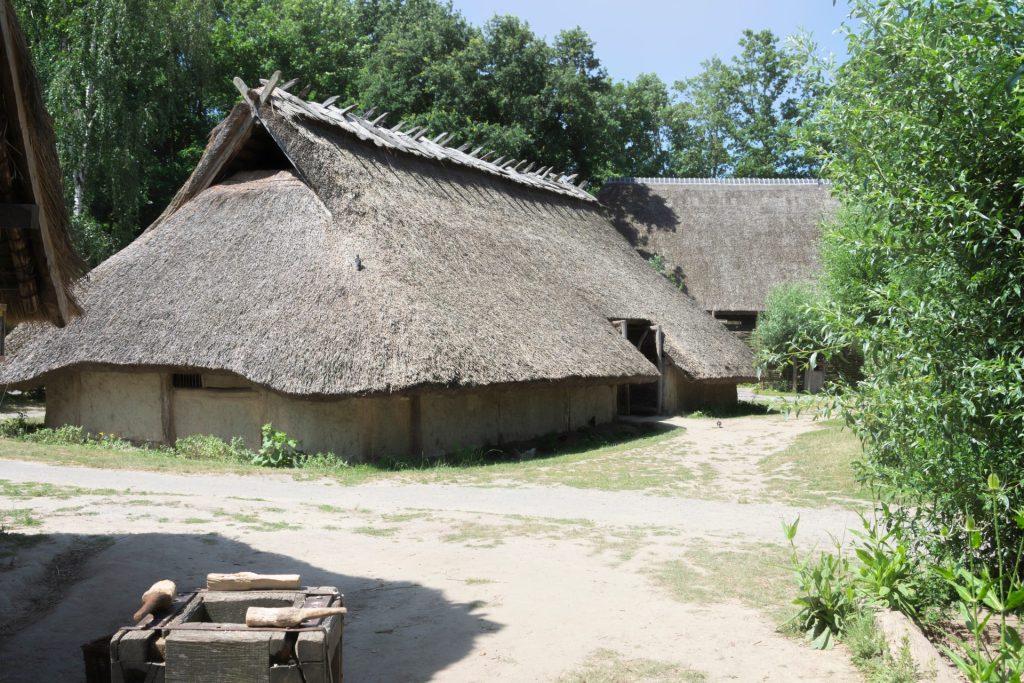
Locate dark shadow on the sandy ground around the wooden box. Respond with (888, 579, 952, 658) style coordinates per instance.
(0, 533, 502, 683)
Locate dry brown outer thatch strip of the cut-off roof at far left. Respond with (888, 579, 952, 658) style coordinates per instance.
(0, 0, 84, 325)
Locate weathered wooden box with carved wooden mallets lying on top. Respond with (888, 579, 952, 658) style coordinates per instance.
(110, 587, 344, 683)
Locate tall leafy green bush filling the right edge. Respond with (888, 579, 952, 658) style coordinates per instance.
(814, 0, 1024, 557)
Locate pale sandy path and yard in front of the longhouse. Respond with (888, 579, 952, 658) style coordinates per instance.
(0, 418, 860, 683)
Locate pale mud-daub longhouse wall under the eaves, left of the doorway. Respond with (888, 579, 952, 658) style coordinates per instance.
(46, 371, 615, 460)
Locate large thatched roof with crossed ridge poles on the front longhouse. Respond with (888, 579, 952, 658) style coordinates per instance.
(0, 76, 752, 395)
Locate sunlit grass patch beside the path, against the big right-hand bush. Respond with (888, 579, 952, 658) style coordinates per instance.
(761, 420, 871, 507)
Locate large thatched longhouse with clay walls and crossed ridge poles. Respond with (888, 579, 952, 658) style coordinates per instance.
(0, 77, 752, 459)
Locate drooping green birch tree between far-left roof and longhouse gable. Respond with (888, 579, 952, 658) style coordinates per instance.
(17, 0, 213, 263)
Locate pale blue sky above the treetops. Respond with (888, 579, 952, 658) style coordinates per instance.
(453, 0, 848, 85)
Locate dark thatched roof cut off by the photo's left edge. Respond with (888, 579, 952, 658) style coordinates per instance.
(0, 0, 81, 325)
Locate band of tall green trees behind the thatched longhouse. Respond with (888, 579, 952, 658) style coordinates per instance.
(18, 0, 823, 263)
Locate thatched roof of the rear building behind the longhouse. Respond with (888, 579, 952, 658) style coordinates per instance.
(598, 178, 837, 311)
